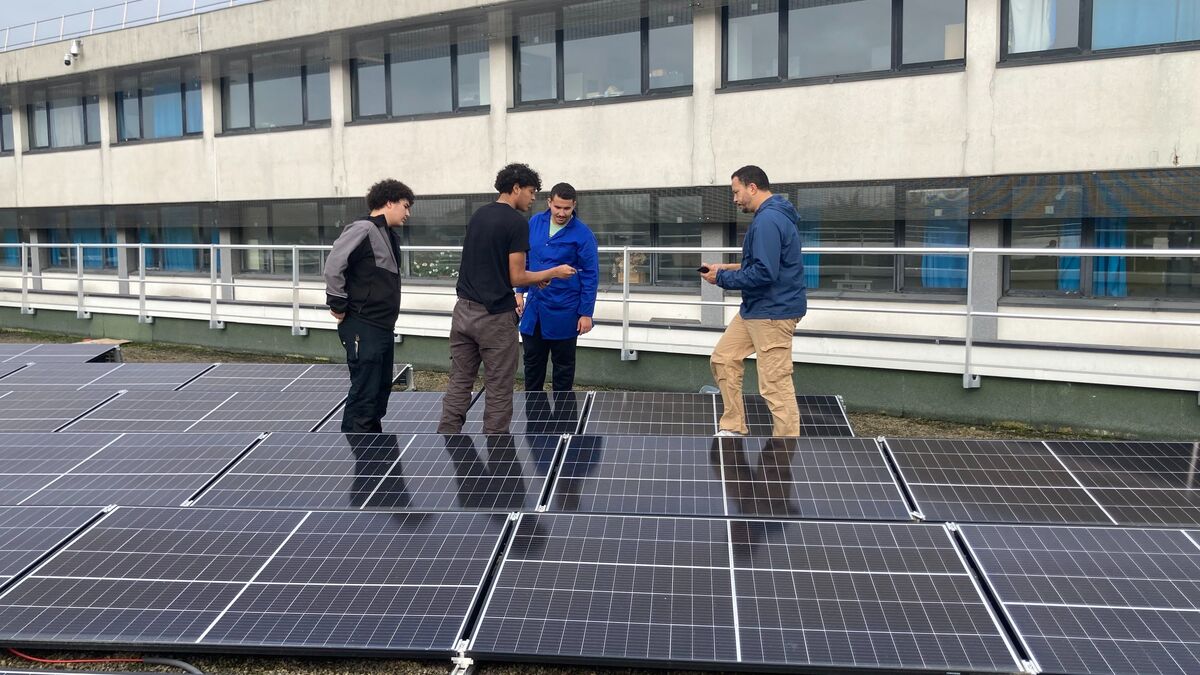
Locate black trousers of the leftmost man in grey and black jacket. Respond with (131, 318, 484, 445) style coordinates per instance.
(337, 315, 396, 434)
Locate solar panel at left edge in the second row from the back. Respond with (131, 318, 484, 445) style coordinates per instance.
(4, 363, 212, 392)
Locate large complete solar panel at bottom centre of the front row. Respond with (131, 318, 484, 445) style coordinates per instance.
(470, 514, 1020, 671)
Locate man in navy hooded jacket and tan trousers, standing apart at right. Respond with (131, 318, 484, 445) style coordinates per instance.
(701, 166, 808, 436)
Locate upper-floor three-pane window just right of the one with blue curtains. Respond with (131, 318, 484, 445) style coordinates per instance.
(221, 47, 330, 131)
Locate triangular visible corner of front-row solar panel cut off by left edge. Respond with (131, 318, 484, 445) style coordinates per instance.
(0, 507, 100, 589)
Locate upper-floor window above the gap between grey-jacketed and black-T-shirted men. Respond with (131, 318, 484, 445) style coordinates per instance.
(350, 24, 491, 119)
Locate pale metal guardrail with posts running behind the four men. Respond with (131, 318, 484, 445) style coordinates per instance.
(0, 243, 1200, 388)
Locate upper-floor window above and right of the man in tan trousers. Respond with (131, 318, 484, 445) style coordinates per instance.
(722, 0, 966, 84)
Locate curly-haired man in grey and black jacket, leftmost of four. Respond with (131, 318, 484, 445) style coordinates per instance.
(325, 179, 416, 434)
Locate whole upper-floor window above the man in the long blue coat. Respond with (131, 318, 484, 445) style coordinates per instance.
(512, 0, 692, 103)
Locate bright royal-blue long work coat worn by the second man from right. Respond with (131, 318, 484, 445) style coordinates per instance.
(517, 210, 600, 340)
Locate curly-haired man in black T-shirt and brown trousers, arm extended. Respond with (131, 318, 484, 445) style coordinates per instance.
(438, 165, 575, 434)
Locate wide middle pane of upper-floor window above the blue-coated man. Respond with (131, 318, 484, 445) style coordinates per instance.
(563, 0, 642, 101)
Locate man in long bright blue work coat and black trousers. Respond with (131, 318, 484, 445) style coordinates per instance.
(516, 183, 600, 392)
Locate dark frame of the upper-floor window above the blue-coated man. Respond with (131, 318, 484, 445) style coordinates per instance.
(509, 0, 696, 110)
